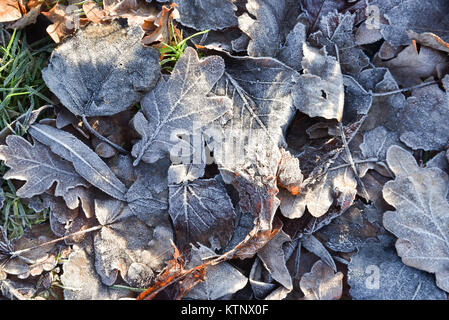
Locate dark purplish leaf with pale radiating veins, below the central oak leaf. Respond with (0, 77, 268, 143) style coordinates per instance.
(169, 166, 236, 251)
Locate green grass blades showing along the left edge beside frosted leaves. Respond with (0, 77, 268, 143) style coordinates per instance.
(0, 25, 55, 238)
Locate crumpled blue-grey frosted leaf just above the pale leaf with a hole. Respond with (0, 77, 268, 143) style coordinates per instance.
(309, 11, 369, 75)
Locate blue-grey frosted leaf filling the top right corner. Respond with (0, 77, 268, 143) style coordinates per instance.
(379, 0, 449, 46)
